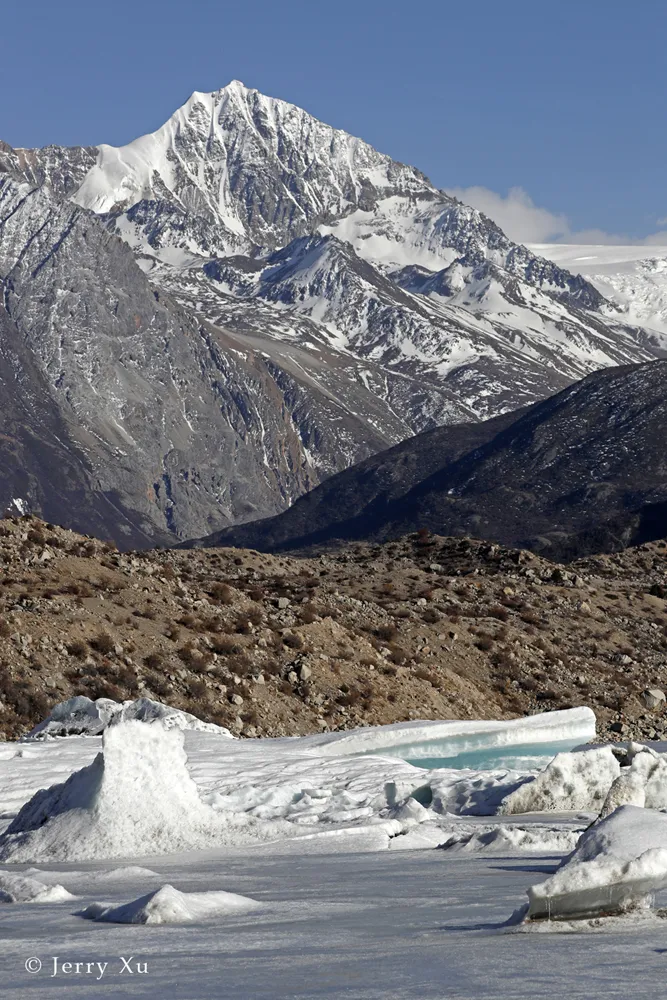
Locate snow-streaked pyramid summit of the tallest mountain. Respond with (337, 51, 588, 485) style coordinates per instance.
(74, 80, 434, 258)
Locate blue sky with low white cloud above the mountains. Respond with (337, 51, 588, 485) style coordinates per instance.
(0, 0, 667, 242)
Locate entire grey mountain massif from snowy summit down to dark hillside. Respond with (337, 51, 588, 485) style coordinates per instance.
(0, 82, 663, 544)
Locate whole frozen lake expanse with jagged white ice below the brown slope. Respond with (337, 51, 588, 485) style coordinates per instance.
(0, 710, 667, 1000)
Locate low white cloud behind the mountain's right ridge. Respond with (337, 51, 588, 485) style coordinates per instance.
(447, 187, 667, 246)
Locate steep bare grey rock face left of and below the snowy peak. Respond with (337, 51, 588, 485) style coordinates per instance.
(0, 180, 396, 544)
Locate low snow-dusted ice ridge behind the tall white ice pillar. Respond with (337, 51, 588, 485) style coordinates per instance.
(24, 695, 233, 740)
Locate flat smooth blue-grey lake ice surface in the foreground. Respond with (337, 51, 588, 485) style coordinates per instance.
(0, 849, 667, 1000)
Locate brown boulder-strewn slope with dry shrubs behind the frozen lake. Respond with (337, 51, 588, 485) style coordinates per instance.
(0, 516, 667, 738)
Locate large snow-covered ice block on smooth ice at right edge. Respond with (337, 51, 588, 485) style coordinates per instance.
(527, 805, 667, 920)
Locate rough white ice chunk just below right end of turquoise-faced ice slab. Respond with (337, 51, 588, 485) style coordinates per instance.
(497, 747, 621, 815)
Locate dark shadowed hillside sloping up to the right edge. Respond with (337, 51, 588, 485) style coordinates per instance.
(198, 361, 667, 561)
